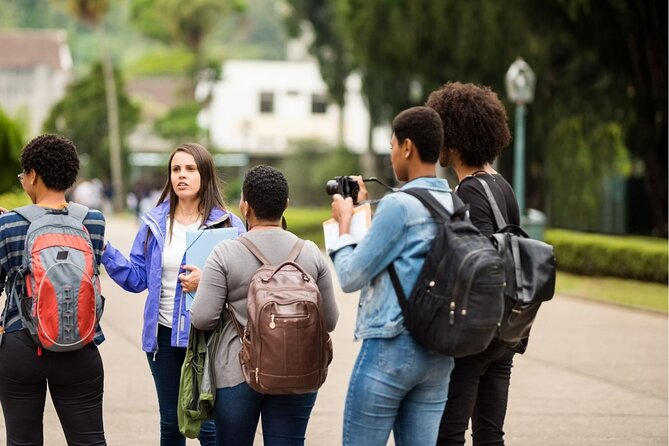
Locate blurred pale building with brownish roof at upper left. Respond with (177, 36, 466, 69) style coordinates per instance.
(0, 29, 72, 138)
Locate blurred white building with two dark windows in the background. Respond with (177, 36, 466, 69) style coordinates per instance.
(198, 60, 390, 155)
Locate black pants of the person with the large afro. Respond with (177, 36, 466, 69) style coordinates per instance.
(437, 342, 516, 446)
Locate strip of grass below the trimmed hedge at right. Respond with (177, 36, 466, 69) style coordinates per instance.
(556, 272, 668, 313)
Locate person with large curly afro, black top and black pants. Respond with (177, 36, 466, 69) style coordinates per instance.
(426, 82, 527, 446)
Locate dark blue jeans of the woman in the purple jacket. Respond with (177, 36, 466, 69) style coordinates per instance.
(146, 325, 216, 446)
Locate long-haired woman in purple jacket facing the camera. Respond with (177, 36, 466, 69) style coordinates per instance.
(102, 143, 244, 446)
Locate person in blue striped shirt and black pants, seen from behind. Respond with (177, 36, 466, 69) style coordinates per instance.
(0, 135, 106, 445)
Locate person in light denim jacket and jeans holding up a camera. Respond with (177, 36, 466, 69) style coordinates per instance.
(329, 107, 453, 446)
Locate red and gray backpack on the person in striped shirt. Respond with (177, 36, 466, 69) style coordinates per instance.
(12, 203, 104, 352)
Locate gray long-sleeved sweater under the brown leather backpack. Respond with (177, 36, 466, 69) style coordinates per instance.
(190, 229, 339, 388)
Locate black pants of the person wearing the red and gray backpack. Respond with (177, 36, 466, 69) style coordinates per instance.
(0, 330, 106, 446)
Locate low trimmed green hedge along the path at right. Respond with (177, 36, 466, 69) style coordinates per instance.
(545, 229, 668, 284)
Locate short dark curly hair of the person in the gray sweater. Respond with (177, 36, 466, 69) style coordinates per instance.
(242, 165, 288, 220)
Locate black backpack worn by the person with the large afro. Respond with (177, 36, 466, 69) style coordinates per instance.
(473, 176, 555, 347)
